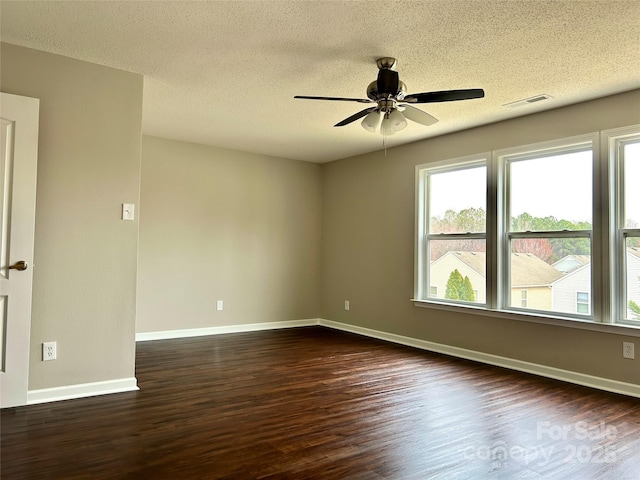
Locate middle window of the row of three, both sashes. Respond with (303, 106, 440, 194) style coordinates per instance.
(496, 138, 594, 315)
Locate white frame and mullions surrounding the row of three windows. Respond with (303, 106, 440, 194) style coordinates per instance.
(413, 131, 640, 337)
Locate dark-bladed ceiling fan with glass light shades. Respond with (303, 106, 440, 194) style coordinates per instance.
(294, 57, 484, 135)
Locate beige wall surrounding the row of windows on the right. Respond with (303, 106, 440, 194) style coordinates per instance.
(321, 90, 640, 384)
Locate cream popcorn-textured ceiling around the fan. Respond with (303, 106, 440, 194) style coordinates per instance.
(0, 0, 640, 162)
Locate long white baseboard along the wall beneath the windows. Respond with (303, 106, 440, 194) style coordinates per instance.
(318, 319, 640, 398)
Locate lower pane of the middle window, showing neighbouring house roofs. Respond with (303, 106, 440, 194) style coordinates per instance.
(509, 238, 591, 314)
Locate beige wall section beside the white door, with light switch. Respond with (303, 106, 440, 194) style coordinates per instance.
(0, 44, 143, 390)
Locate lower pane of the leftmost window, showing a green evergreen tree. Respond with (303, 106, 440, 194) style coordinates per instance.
(429, 239, 487, 304)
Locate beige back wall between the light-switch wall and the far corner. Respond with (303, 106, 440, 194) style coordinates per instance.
(137, 137, 322, 332)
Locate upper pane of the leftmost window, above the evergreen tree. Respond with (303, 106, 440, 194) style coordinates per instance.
(428, 166, 487, 233)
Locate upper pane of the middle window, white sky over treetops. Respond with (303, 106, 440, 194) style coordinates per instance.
(509, 150, 592, 232)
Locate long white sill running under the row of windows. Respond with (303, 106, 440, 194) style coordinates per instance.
(411, 299, 640, 337)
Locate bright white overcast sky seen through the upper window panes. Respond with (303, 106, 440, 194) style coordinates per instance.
(430, 143, 640, 229)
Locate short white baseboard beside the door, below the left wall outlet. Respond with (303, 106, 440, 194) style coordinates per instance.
(27, 377, 140, 405)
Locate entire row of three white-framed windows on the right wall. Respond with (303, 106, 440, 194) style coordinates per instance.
(415, 125, 640, 325)
